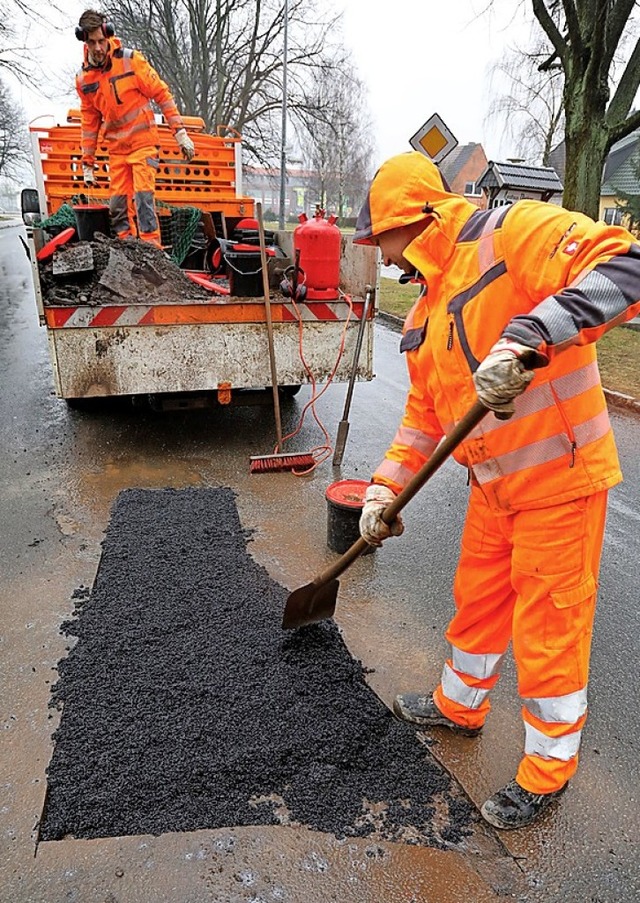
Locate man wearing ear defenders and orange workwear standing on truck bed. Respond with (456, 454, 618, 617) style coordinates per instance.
(76, 9, 194, 247)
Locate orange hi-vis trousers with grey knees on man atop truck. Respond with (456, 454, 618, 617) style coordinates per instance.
(109, 147, 161, 247)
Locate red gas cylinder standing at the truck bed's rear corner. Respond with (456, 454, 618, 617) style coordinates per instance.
(293, 208, 342, 301)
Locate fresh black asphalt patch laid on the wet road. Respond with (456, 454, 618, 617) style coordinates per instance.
(39, 489, 478, 848)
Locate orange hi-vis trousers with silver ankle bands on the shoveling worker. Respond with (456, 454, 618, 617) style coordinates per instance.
(434, 485, 607, 793)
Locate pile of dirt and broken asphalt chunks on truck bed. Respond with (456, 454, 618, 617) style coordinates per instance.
(39, 233, 212, 306)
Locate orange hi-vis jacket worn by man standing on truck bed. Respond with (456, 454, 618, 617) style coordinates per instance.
(76, 38, 184, 166)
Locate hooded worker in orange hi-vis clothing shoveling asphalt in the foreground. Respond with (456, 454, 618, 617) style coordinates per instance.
(354, 152, 640, 828)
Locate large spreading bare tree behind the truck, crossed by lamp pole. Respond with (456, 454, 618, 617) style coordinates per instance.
(108, 0, 348, 163)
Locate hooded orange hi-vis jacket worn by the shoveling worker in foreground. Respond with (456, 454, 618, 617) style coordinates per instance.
(354, 152, 640, 513)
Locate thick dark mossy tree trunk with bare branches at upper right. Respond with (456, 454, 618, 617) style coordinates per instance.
(532, 0, 640, 217)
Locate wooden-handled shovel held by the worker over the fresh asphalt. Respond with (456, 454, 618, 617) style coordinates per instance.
(282, 401, 488, 630)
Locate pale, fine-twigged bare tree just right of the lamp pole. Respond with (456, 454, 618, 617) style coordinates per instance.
(298, 64, 374, 217)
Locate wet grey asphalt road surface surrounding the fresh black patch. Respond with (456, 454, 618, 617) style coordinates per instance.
(0, 219, 640, 903)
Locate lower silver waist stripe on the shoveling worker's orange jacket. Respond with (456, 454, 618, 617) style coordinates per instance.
(472, 410, 611, 483)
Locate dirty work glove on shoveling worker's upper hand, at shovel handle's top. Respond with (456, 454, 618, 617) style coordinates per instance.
(473, 339, 540, 420)
